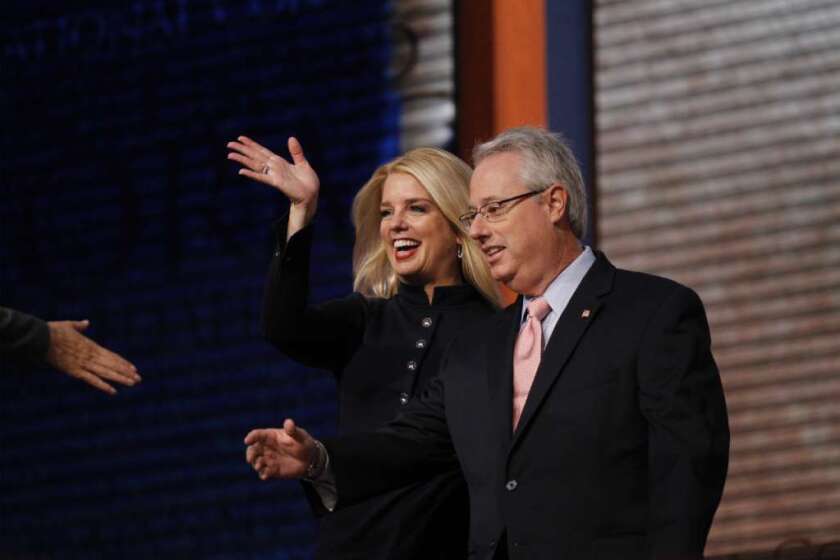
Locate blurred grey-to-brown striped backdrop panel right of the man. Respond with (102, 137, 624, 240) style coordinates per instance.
(594, 0, 840, 555)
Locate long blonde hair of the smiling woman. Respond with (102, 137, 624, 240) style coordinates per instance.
(353, 148, 500, 307)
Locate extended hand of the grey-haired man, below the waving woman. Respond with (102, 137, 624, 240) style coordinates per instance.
(245, 418, 317, 480)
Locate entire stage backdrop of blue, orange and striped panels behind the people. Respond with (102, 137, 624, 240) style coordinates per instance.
(0, 0, 840, 558)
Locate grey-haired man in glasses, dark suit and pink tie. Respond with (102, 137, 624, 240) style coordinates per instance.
(246, 128, 729, 560)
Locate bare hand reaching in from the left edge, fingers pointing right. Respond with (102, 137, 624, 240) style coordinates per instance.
(47, 321, 141, 395)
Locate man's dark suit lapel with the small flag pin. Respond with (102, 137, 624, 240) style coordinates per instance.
(511, 253, 615, 449)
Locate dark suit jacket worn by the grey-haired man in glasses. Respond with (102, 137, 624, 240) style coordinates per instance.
(325, 254, 729, 560)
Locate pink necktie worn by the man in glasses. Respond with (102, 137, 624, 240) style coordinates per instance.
(513, 298, 551, 430)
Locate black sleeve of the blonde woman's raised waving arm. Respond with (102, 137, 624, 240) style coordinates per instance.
(262, 219, 368, 371)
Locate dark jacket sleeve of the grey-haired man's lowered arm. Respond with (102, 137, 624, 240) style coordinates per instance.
(638, 286, 729, 560)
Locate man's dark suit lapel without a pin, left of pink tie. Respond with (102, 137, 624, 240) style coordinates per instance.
(486, 297, 522, 441)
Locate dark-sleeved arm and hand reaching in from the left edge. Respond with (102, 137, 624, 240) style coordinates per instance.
(0, 307, 140, 394)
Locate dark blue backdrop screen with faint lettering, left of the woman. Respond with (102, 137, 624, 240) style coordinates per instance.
(0, 0, 399, 558)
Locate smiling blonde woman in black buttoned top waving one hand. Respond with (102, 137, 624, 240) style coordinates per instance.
(228, 136, 499, 560)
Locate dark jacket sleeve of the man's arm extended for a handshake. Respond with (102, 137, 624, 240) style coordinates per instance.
(324, 366, 458, 507)
